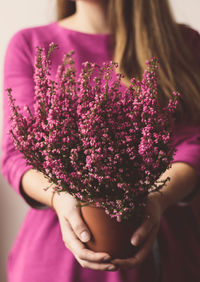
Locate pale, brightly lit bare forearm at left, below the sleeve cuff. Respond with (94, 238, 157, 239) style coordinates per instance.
(21, 169, 53, 206)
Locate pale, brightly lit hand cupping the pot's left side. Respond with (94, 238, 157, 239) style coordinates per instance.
(53, 192, 117, 271)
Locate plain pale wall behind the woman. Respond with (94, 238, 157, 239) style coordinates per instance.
(0, 0, 200, 282)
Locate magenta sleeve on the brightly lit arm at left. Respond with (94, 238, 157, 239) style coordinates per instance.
(1, 30, 46, 208)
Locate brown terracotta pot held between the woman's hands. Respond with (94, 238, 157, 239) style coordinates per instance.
(81, 206, 141, 258)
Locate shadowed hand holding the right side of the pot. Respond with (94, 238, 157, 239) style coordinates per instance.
(111, 192, 163, 268)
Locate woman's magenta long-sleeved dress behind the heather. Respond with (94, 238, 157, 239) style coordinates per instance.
(2, 22, 200, 282)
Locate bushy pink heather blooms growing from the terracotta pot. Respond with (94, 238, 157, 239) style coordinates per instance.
(8, 43, 179, 221)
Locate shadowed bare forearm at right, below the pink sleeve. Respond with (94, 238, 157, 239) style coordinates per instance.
(155, 162, 199, 210)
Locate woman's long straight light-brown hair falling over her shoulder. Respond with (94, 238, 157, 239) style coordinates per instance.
(57, 0, 200, 124)
